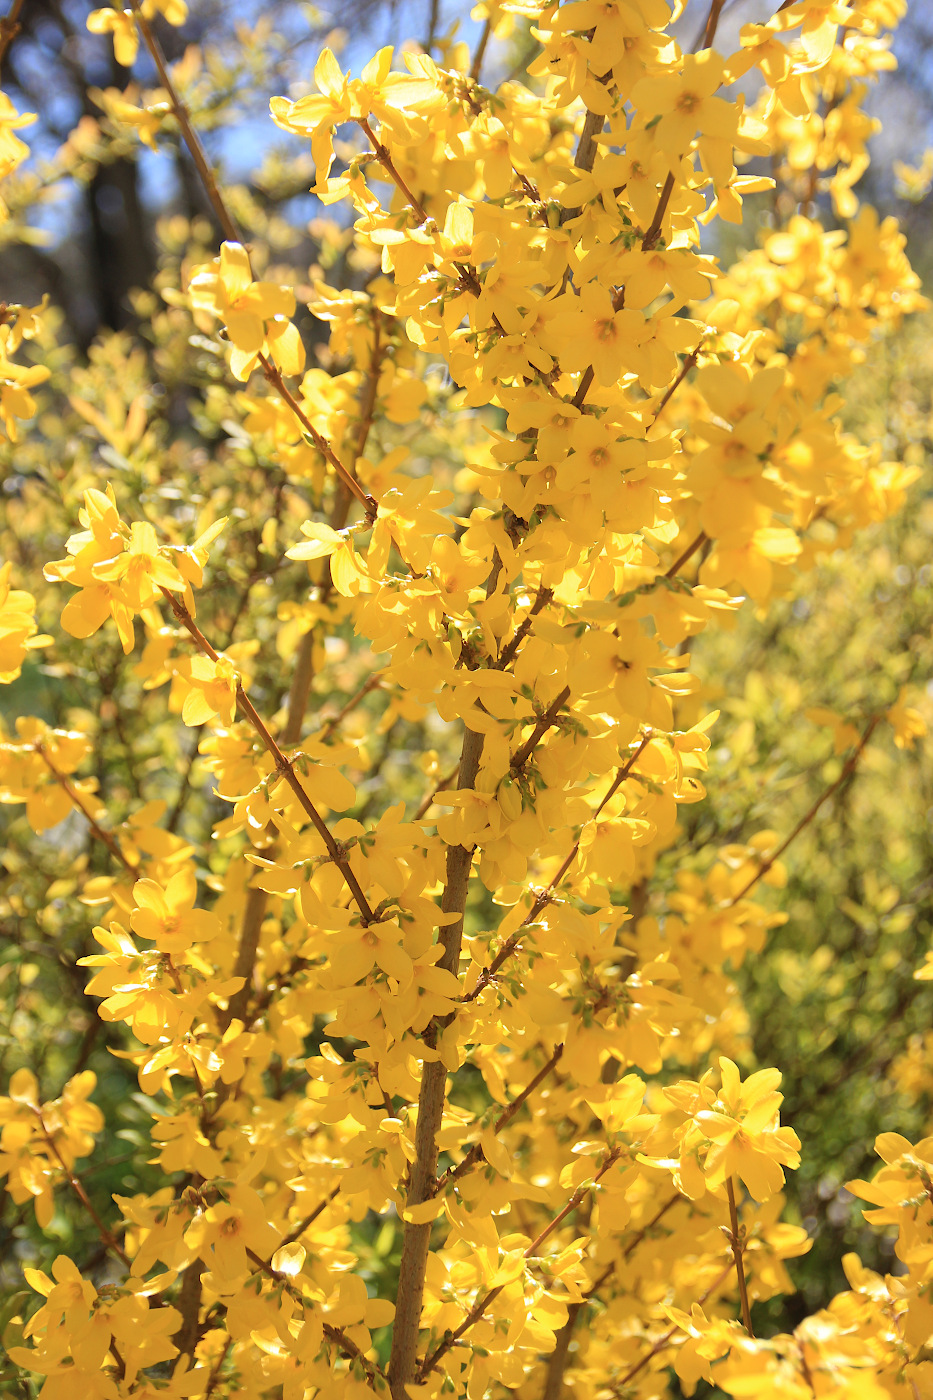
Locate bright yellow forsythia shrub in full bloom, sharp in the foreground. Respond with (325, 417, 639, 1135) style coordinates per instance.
(0, 0, 933, 1400)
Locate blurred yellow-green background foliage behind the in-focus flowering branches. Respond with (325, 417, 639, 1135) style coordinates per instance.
(0, 0, 933, 1377)
